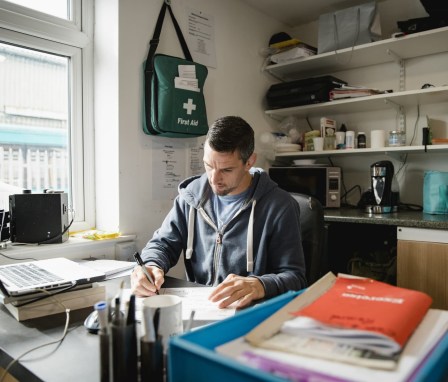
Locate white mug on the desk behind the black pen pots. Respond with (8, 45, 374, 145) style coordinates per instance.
(143, 294, 184, 351)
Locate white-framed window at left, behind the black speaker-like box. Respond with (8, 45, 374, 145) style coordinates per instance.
(0, 0, 95, 230)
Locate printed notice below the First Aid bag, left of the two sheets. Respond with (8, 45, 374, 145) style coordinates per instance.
(152, 142, 186, 200)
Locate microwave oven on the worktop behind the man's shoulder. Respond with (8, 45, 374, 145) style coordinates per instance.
(269, 165, 341, 208)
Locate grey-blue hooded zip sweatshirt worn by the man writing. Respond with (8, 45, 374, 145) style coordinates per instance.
(142, 168, 306, 298)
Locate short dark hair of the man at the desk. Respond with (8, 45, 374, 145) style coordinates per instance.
(207, 116, 255, 163)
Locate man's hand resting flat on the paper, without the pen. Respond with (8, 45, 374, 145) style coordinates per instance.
(208, 274, 265, 309)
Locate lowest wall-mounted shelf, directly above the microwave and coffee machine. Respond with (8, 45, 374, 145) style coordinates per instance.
(275, 145, 448, 158)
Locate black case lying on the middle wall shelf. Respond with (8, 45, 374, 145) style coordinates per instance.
(266, 76, 347, 109)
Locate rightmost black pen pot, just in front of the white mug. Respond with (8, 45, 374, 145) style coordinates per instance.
(140, 339, 164, 382)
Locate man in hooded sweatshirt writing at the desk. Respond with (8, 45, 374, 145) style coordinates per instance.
(131, 116, 306, 308)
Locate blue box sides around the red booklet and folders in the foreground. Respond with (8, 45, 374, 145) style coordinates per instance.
(168, 292, 448, 382)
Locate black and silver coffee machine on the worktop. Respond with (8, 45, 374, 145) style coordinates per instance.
(366, 160, 399, 214)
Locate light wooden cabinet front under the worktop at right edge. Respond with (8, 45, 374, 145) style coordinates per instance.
(397, 227, 448, 309)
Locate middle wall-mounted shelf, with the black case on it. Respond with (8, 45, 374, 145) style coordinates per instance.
(265, 86, 448, 120)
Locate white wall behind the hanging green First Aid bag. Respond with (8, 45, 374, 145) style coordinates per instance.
(95, 0, 283, 276)
